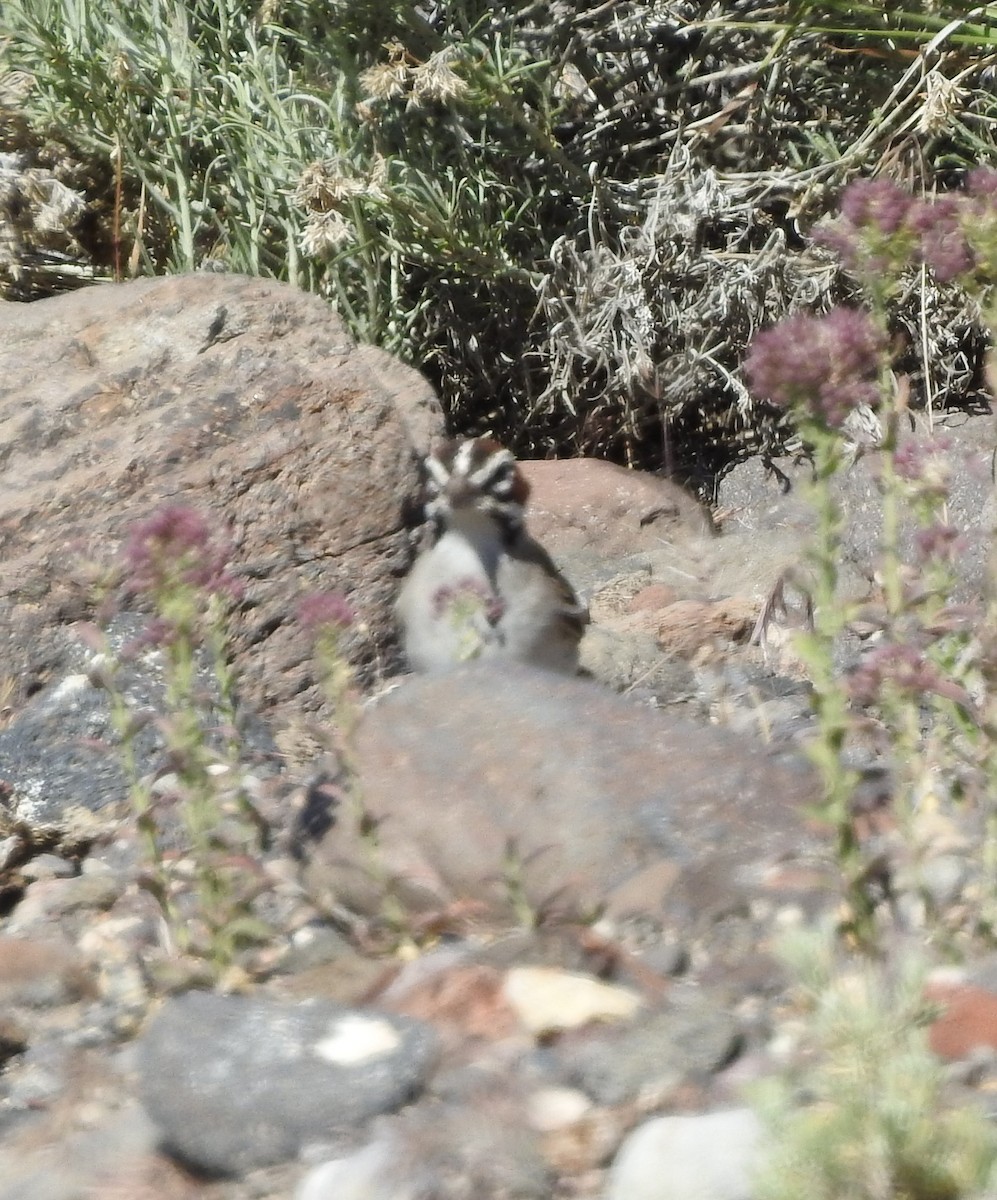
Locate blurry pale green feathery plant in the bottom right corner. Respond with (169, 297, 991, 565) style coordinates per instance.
(752, 931, 997, 1200)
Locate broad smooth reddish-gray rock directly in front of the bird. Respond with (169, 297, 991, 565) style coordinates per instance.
(306, 664, 816, 919)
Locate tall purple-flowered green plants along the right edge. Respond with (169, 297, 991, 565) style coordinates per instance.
(746, 169, 997, 944)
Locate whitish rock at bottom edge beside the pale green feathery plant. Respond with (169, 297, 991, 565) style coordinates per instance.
(605, 1109, 763, 1200)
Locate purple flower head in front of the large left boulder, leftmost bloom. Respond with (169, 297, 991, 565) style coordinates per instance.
(124, 504, 241, 599)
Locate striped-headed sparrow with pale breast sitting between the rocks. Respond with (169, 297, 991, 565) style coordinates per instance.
(396, 437, 588, 674)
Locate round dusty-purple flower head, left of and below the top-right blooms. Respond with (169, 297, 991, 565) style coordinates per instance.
(745, 308, 884, 427)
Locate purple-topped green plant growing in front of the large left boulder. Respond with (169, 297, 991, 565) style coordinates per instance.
(88, 505, 272, 985)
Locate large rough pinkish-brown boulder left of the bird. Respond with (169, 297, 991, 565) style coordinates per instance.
(0, 274, 442, 708)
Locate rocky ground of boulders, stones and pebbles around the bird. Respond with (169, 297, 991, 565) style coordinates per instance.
(0, 275, 997, 1200)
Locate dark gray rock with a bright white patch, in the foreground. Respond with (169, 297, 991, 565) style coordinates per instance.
(138, 992, 437, 1174)
